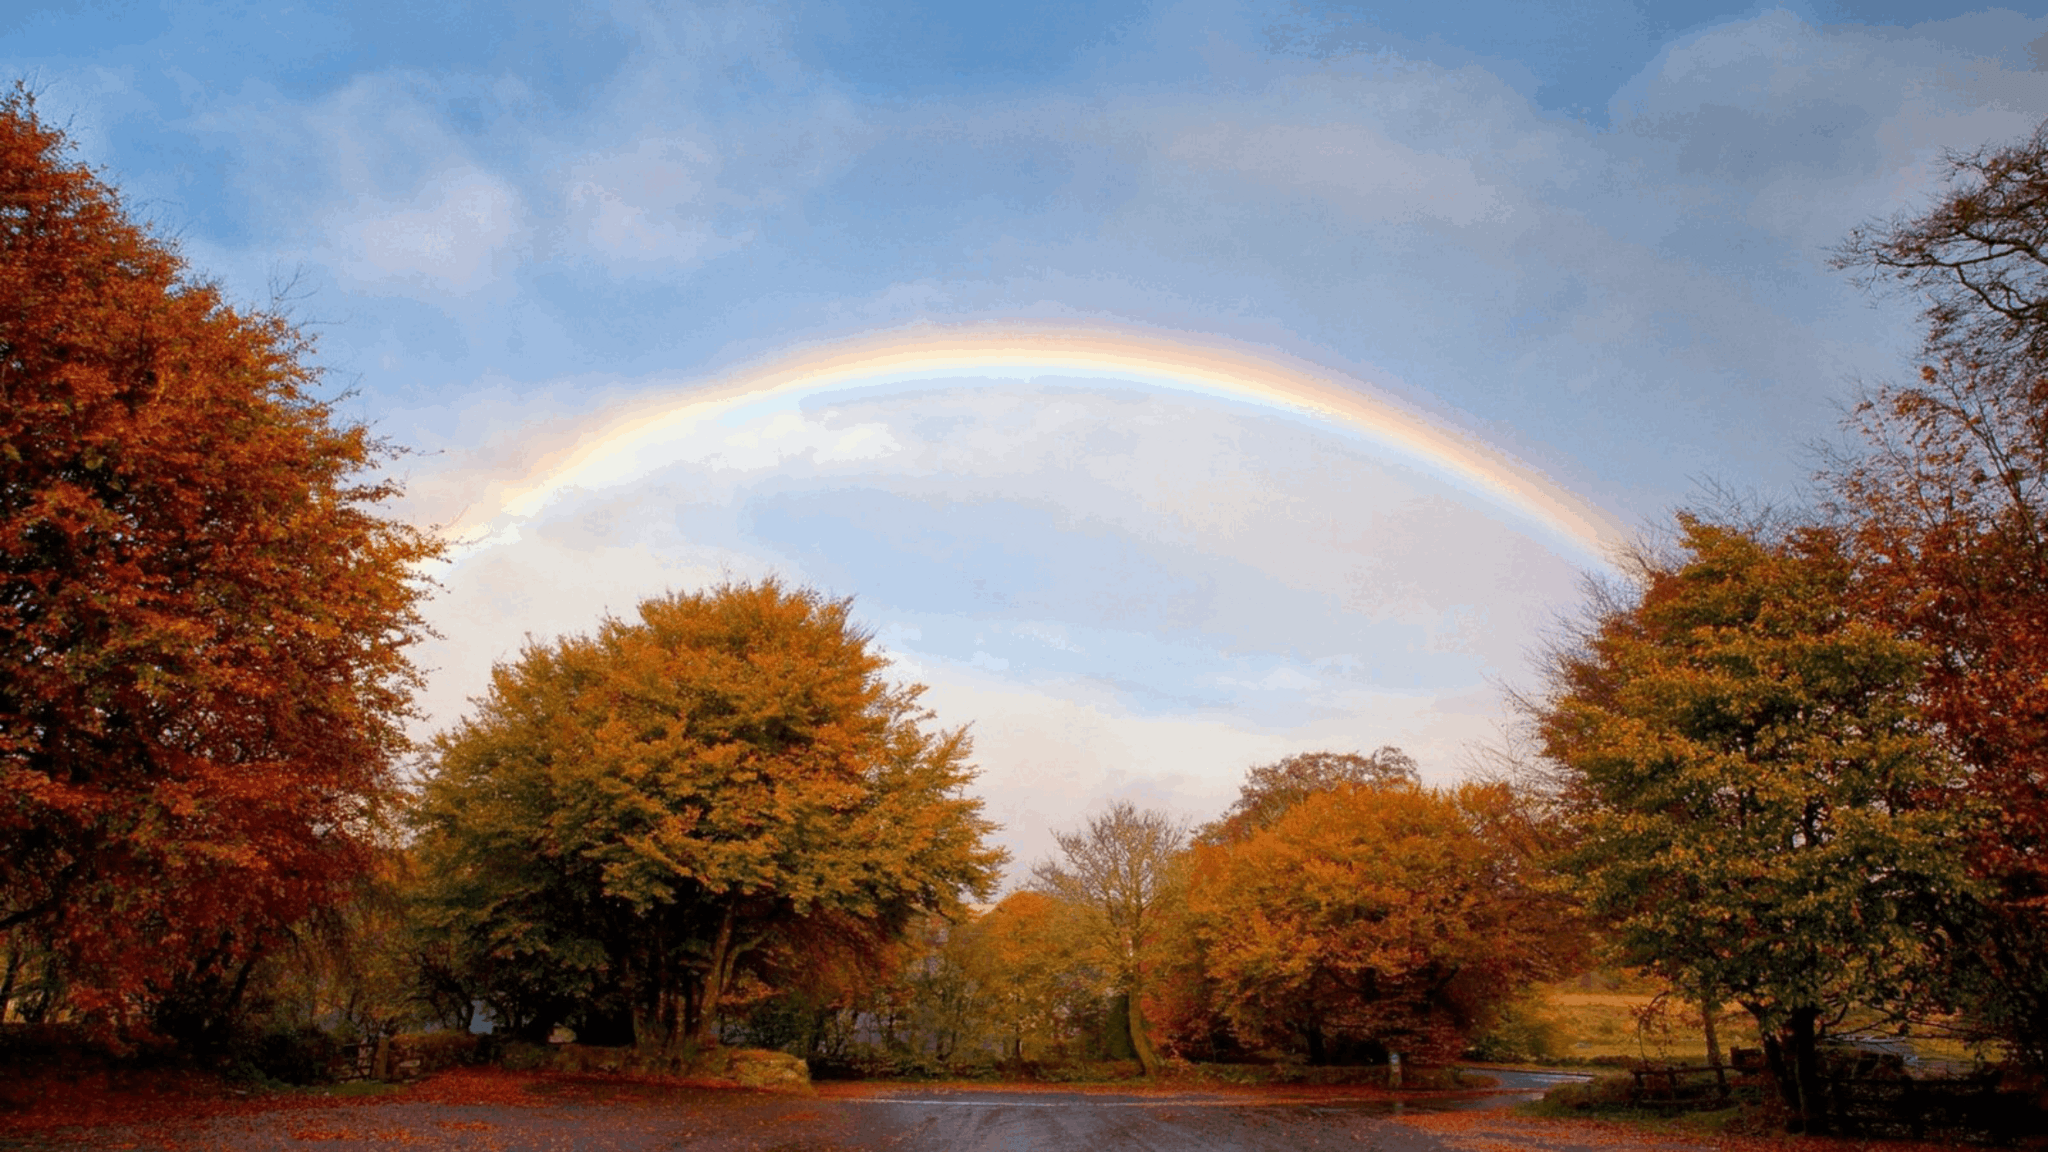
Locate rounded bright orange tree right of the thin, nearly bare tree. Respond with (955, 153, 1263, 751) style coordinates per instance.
(1188, 783, 1565, 1064)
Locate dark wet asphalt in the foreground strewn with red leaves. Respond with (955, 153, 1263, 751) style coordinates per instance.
(19, 1072, 1597, 1152)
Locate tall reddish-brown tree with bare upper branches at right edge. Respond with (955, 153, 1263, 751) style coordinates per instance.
(1825, 125, 2048, 1070)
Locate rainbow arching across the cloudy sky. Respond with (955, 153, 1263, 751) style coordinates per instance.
(451, 322, 1626, 562)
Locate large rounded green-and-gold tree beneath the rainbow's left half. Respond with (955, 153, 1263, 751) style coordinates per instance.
(418, 580, 1004, 1054)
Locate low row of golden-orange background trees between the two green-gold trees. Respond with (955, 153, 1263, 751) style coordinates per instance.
(733, 748, 1587, 1072)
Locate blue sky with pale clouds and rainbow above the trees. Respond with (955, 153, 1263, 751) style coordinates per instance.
(0, 0, 2048, 865)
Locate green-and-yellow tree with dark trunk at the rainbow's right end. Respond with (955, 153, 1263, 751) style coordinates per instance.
(1532, 515, 1974, 1129)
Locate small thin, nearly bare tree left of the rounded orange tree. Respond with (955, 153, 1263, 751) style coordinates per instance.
(1032, 799, 1188, 1076)
